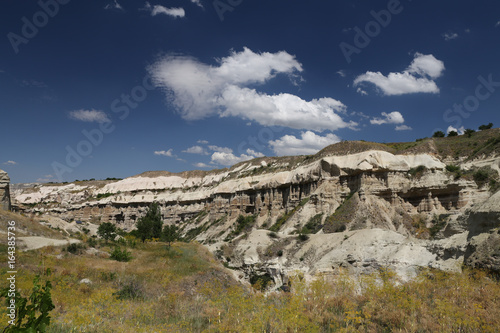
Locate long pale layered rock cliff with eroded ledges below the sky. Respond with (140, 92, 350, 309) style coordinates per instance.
(9, 134, 500, 287)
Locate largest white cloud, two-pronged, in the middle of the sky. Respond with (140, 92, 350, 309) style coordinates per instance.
(148, 47, 356, 131)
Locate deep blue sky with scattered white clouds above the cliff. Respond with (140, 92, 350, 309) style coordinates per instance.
(0, 0, 500, 183)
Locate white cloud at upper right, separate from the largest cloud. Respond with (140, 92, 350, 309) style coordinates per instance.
(354, 52, 445, 96)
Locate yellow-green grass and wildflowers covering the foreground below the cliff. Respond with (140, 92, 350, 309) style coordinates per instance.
(0, 235, 500, 332)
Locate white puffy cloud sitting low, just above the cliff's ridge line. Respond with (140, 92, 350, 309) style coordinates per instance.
(269, 131, 340, 156)
